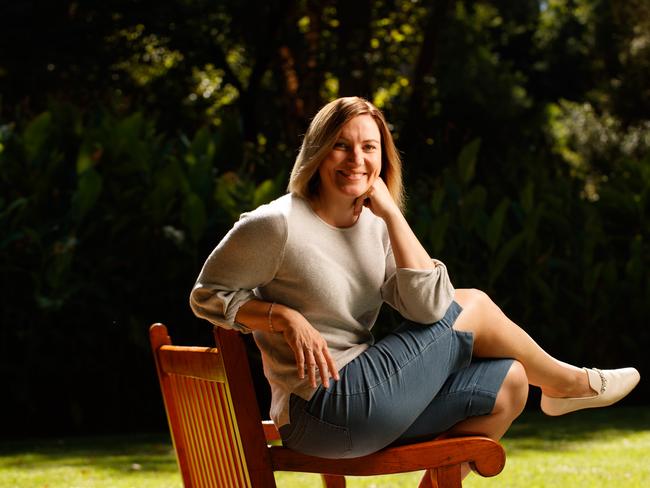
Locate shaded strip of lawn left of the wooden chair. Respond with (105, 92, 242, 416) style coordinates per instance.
(0, 434, 178, 473)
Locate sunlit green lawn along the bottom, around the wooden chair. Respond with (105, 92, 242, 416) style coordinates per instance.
(0, 407, 650, 488)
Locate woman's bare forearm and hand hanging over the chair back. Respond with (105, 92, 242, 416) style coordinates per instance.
(236, 299, 339, 388)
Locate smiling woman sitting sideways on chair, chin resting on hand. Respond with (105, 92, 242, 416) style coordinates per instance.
(190, 97, 639, 471)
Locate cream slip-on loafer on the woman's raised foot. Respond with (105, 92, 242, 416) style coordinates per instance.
(541, 368, 641, 416)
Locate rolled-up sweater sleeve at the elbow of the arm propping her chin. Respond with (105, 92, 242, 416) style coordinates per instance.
(381, 249, 454, 324)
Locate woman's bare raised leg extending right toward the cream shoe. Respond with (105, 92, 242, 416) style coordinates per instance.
(454, 289, 595, 397)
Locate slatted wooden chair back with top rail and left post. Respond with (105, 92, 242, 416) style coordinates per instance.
(150, 324, 255, 488)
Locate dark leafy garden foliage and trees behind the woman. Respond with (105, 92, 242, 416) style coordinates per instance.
(0, 0, 650, 436)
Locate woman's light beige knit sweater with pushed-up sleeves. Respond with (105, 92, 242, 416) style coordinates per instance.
(190, 194, 454, 427)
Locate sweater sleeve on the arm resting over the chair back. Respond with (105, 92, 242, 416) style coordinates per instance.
(190, 207, 287, 333)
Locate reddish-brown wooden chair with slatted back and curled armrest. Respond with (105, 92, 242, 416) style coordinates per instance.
(150, 324, 505, 488)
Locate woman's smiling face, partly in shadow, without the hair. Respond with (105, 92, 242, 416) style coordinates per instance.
(318, 114, 381, 201)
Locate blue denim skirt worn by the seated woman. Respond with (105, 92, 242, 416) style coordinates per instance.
(280, 302, 512, 458)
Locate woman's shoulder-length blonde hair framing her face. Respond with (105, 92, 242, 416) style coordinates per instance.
(288, 97, 404, 210)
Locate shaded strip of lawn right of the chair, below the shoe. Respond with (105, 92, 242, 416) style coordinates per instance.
(504, 407, 650, 451)
